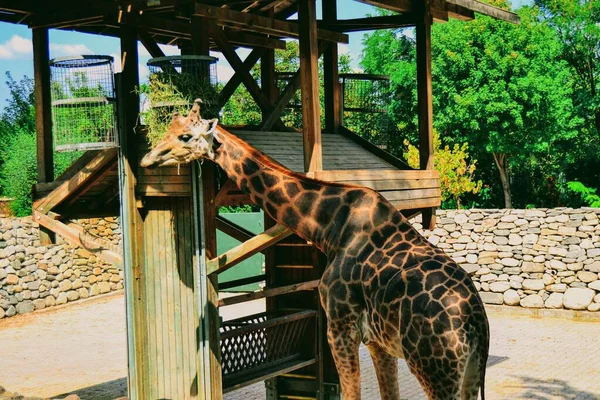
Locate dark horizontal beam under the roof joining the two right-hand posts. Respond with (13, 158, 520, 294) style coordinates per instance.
(319, 13, 417, 32)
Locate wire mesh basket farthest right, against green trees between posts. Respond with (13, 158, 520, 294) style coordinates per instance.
(340, 74, 390, 149)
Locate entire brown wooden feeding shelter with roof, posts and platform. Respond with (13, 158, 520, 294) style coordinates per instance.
(0, 0, 518, 400)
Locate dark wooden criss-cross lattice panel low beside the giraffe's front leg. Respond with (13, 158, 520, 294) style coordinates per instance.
(221, 310, 316, 386)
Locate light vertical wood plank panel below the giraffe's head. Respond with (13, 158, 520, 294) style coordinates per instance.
(142, 197, 199, 399)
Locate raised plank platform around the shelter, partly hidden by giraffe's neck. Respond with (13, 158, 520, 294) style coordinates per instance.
(35, 130, 440, 218)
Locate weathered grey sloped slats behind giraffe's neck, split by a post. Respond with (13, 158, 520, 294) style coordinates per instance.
(232, 131, 398, 172)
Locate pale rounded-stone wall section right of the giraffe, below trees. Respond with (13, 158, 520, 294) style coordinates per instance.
(415, 208, 600, 311)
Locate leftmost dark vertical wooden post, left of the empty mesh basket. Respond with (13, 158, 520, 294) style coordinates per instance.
(32, 28, 54, 183)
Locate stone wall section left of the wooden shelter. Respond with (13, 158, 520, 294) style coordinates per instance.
(0, 218, 123, 319)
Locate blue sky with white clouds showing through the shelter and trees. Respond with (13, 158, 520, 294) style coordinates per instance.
(0, 0, 531, 108)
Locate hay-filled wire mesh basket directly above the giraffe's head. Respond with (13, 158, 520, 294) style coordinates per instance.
(143, 55, 220, 143)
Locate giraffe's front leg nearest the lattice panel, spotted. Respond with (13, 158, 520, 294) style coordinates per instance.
(327, 321, 360, 400)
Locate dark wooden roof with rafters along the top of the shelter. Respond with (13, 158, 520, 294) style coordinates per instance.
(0, 0, 518, 48)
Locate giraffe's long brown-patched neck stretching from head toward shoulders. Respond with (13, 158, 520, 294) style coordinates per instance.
(214, 128, 352, 253)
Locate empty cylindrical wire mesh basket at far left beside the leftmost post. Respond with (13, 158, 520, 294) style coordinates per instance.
(50, 55, 117, 151)
